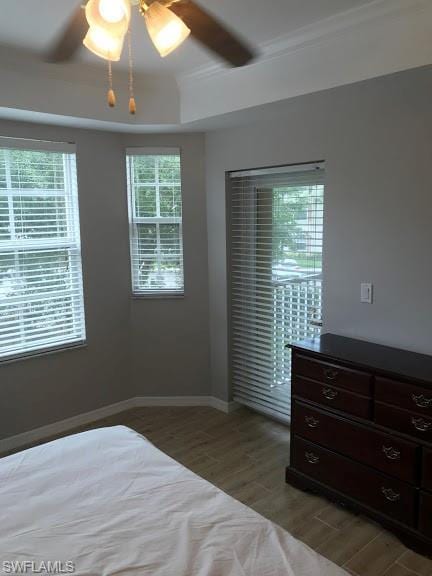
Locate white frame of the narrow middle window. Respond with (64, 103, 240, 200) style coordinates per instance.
(125, 146, 185, 300)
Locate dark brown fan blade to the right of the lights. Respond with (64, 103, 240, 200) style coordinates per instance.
(169, 0, 255, 66)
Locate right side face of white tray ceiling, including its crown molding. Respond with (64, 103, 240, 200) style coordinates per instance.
(178, 0, 432, 124)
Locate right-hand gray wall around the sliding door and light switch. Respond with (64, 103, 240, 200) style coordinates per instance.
(206, 67, 432, 399)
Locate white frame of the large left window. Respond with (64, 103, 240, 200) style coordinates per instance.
(0, 136, 87, 365)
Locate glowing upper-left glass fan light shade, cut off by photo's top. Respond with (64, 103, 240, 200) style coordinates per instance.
(85, 0, 131, 36)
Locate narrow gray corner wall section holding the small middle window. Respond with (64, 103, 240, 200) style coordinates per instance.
(116, 134, 210, 396)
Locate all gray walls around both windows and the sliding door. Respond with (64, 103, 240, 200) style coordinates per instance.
(0, 68, 432, 438)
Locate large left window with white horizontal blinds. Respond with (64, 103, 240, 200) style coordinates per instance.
(0, 139, 85, 359)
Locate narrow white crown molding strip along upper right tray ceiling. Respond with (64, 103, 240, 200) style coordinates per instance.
(176, 0, 430, 88)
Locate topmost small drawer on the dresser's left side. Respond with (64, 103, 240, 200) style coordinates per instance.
(293, 354, 372, 396)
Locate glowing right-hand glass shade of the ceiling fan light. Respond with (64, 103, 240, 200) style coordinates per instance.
(144, 2, 190, 58)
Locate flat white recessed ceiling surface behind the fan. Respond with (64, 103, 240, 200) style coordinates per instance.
(0, 0, 371, 75)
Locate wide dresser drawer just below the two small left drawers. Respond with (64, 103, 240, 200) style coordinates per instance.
(291, 401, 420, 483)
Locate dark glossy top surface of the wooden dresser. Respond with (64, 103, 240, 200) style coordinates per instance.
(290, 334, 432, 388)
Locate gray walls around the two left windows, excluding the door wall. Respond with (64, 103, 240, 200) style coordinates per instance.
(0, 121, 209, 438)
